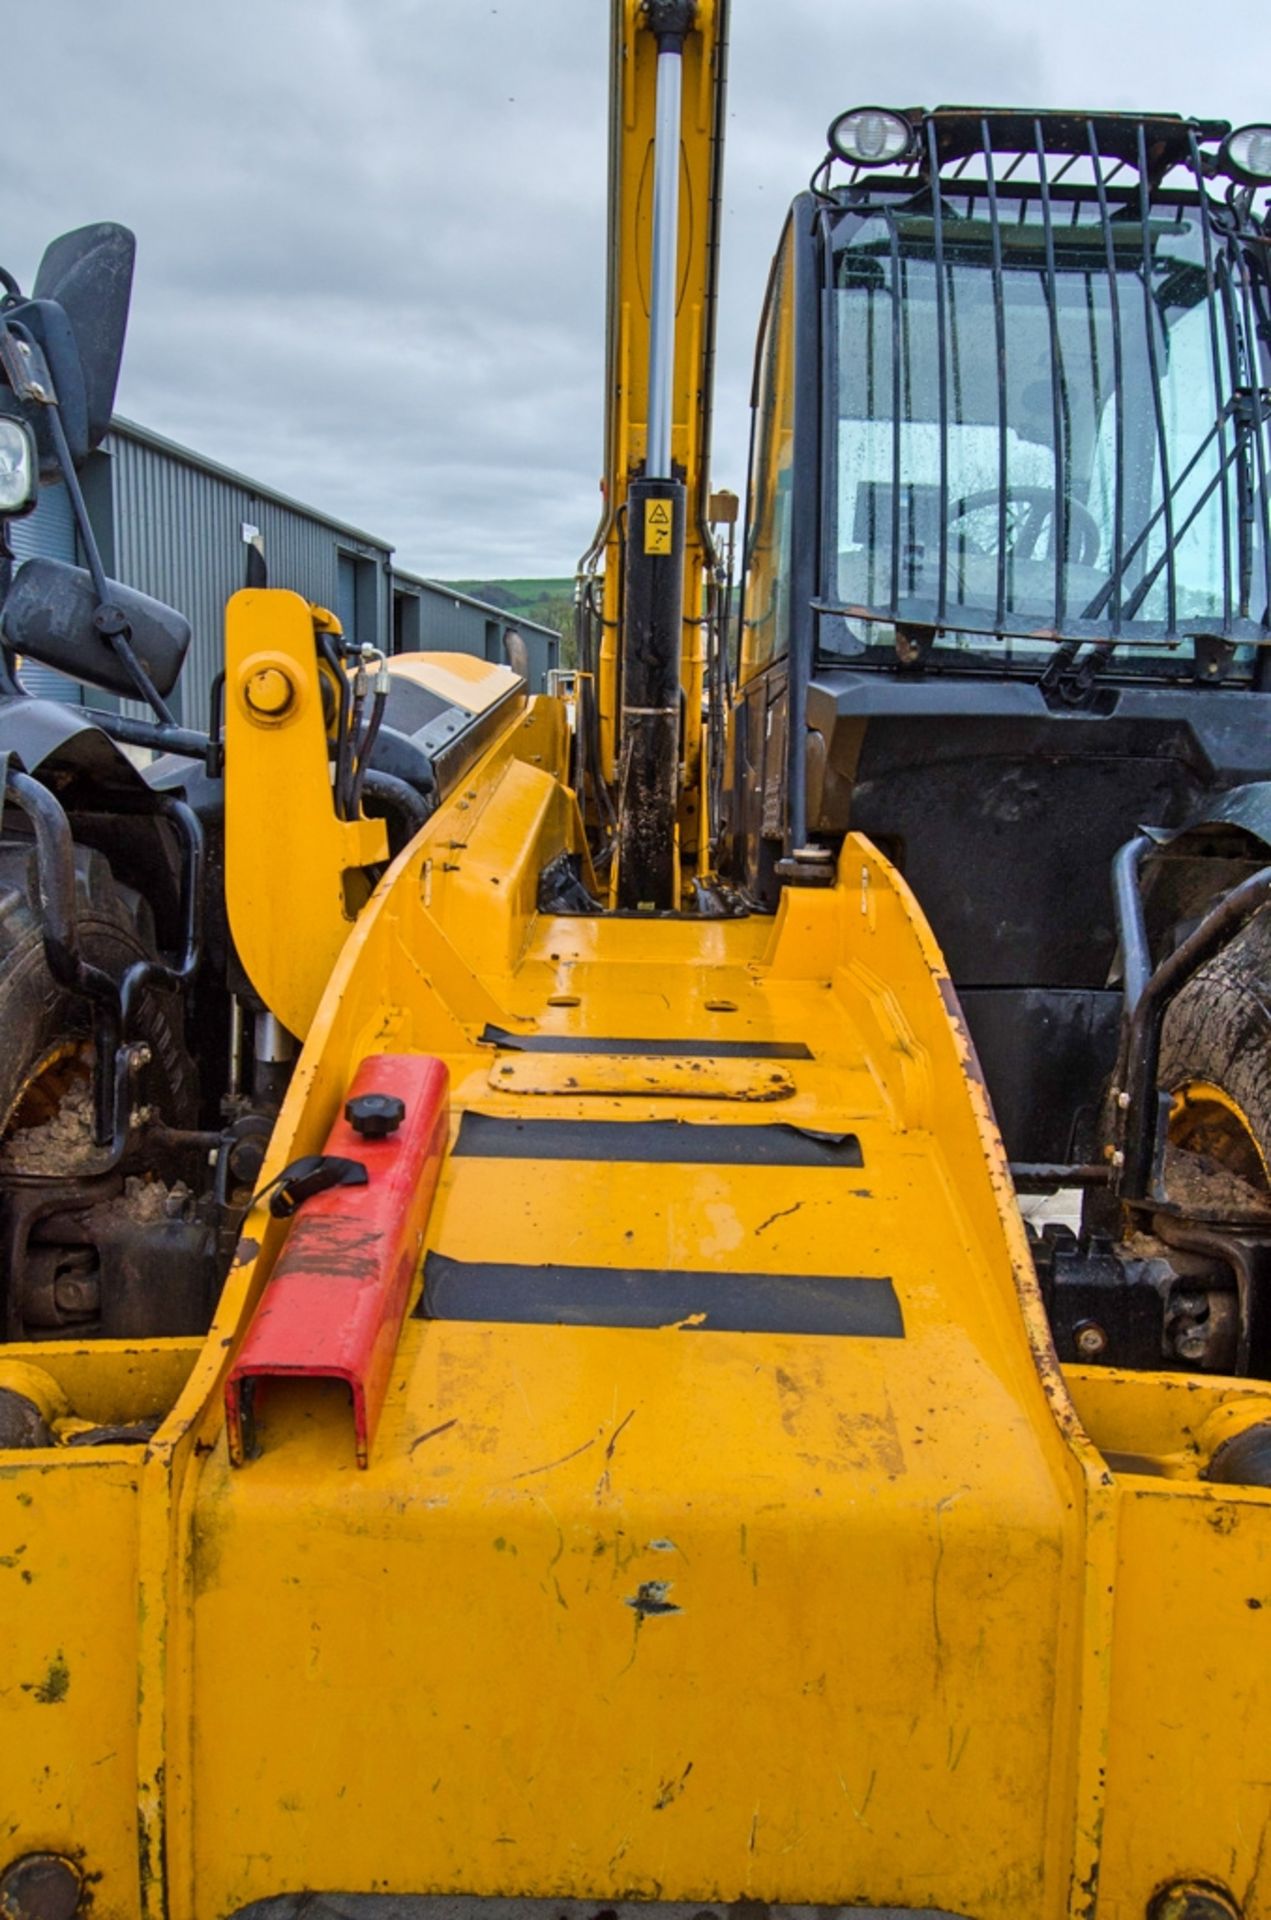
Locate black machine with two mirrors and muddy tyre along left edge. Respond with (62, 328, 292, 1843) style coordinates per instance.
(0, 225, 447, 1340)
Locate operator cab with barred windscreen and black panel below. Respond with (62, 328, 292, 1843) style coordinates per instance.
(731, 108, 1271, 1162)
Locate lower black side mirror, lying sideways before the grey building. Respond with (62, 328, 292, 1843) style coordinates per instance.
(0, 559, 190, 699)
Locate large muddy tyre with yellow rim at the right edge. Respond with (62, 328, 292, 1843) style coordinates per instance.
(1160, 912, 1271, 1194)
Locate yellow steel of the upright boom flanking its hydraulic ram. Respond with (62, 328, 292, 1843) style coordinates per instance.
(599, 0, 728, 858)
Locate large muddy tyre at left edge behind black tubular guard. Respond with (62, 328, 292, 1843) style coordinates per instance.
(0, 837, 198, 1173)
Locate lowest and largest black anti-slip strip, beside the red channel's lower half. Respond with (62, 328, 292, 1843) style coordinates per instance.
(415, 1254, 904, 1340)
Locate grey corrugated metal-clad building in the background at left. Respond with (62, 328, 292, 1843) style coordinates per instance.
(1, 419, 561, 728)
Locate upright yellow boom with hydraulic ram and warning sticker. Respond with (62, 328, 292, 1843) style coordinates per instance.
(580, 0, 728, 908)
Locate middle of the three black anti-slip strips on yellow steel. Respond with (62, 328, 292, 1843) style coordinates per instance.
(451, 1114, 864, 1167)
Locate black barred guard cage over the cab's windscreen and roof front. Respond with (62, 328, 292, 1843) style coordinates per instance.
(812, 108, 1271, 685)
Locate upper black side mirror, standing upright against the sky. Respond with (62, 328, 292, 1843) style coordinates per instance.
(6, 221, 136, 476)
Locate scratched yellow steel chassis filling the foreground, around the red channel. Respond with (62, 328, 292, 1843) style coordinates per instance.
(0, 597, 1271, 1920)
